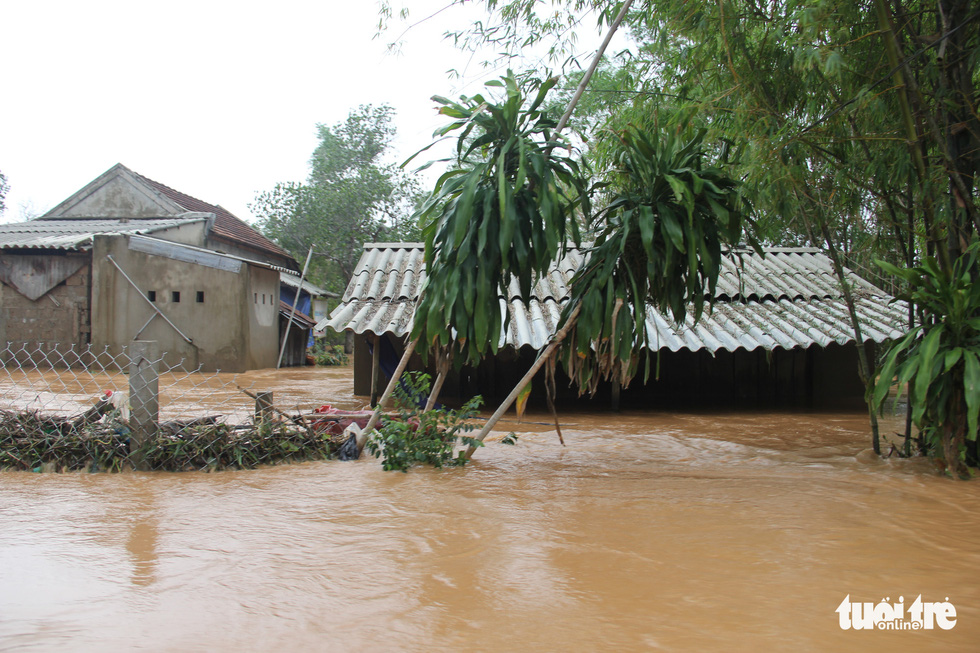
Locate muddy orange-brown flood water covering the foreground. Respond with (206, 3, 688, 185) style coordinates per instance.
(0, 369, 980, 651)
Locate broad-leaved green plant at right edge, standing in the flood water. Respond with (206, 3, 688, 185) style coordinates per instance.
(871, 242, 980, 473)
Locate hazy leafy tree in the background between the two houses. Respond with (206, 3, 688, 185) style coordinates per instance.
(249, 106, 419, 292)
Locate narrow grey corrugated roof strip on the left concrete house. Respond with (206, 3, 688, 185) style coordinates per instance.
(0, 218, 205, 250)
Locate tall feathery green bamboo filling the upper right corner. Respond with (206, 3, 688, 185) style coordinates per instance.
(386, 0, 980, 469)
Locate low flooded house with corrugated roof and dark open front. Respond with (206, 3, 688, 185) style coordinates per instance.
(318, 243, 908, 406)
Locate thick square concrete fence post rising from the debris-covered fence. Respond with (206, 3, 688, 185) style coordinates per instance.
(129, 340, 160, 469)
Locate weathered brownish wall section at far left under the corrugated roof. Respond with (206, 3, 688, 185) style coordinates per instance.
(0, 252, 91, 358)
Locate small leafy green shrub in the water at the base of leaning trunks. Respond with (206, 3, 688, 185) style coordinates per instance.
(366, 373, 483, 472)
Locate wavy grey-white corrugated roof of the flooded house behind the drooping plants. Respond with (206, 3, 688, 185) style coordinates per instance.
(317, 243, 907, 352)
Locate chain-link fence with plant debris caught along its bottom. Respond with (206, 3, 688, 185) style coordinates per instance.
(0, 342, 366, 471)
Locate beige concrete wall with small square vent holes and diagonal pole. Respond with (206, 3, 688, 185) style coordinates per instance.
(92, 236, 279, 372)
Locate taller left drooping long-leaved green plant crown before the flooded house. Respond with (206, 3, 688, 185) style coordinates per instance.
(412, 74, 588, 365)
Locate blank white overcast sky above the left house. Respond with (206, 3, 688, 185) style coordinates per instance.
(0, 0, 608, 222)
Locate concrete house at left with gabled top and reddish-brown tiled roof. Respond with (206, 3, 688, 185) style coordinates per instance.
(0, 165, 298, 372)
